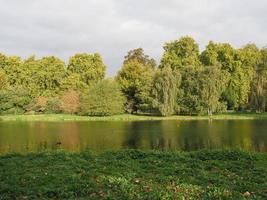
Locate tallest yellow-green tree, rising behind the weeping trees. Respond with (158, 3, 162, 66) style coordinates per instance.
(160, 36, 202, 114)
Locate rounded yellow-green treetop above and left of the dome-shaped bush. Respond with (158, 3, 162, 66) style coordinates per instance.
(68, 53, 106, 85)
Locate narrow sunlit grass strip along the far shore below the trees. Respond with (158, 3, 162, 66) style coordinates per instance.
(0, 113, 267, 121)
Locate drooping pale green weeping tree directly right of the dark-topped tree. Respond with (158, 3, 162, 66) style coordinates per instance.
(152, 67, 181, 116)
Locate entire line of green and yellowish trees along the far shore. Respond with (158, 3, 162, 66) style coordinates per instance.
(0, 36, 267, 116)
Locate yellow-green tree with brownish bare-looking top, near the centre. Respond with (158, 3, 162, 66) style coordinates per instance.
(117, 49, 155, 113)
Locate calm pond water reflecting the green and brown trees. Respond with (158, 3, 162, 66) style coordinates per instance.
(0, 120, 267, 154)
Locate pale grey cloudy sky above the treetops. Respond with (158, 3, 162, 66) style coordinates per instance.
(0, 0, 267, 75)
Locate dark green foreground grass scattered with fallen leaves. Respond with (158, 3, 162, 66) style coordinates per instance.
(0, 150, 267, 199)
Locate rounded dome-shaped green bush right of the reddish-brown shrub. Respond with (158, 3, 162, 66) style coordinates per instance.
(81, 79, 125, 116)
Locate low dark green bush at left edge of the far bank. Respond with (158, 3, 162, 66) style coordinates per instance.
(0, 88, 32, 114)
